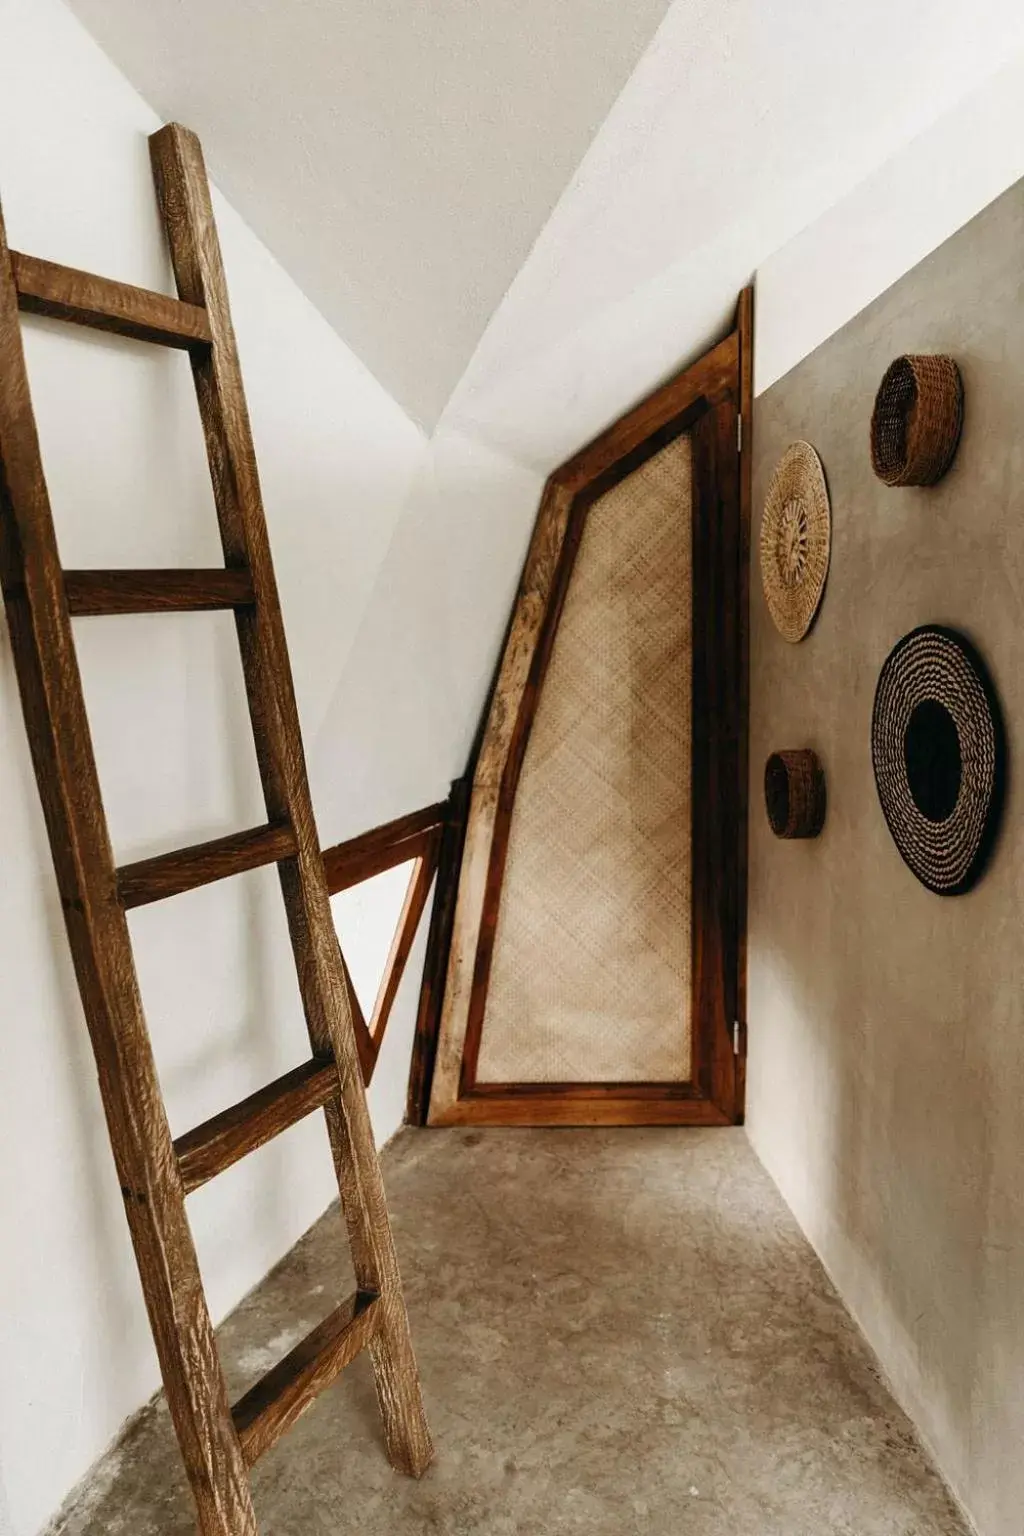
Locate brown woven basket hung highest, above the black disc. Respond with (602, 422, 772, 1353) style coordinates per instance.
(870, 355, 964, 485)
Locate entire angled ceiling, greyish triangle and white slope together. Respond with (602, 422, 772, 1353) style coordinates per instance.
(69, 0, 1024, 445)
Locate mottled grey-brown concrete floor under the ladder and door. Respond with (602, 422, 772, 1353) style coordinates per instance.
(60, 1130, 967, 1536)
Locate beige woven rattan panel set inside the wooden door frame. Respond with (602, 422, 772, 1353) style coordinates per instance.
(476, 435, 692, 1083)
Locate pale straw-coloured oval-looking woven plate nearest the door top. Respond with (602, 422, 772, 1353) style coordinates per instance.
(761, 442, 832, 642)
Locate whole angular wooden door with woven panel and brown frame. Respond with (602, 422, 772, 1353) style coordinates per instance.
(430, 293, 751, 1124)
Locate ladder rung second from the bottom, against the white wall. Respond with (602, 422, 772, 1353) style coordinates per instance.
(173, 1057, 338, 1195)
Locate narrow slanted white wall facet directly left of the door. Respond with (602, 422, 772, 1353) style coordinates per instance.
(312, 430, 542, 836)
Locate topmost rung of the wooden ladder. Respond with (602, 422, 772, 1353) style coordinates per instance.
(11, 250, 212, 347)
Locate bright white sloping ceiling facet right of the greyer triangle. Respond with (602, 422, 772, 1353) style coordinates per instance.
(444, 0, 1024, 473)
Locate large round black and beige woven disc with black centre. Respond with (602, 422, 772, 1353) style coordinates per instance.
(870, 625, 1006, 895)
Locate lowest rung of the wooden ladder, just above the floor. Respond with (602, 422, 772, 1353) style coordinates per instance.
(232, 1290, 381, 1467)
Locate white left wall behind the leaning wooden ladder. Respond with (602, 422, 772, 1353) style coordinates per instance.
(0, 0, 432, 1536)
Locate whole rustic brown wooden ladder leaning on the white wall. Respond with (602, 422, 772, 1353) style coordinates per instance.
(0, 124, 431, 1536)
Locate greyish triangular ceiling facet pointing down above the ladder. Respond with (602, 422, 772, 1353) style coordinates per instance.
(71, 0, 668, 427)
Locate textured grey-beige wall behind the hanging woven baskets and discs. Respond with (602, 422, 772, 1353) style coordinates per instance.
(749, 183, 1024, 1536)
